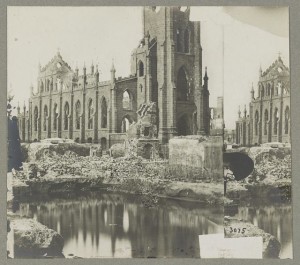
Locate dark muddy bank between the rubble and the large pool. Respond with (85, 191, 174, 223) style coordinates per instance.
(12, 176, 224, 206)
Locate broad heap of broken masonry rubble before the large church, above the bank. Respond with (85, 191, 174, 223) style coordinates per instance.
(14, 145, 212, 183)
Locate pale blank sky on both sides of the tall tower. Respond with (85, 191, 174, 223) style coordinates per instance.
(7, 7, 289, 128)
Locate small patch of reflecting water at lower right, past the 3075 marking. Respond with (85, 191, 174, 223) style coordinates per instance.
(235, 204, 293, 258)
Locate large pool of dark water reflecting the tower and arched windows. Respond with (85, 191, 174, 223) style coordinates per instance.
(16, 194, 224, 257)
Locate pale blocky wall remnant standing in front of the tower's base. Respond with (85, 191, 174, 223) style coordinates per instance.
(169, 135, 223, 181)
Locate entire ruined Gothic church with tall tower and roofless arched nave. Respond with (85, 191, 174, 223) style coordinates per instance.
(18, 7, 210, 149)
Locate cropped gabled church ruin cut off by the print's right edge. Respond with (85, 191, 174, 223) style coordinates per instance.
(236, 56, 291, 146)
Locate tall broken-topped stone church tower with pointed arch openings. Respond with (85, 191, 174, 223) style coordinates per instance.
(131, 6, 210, 143)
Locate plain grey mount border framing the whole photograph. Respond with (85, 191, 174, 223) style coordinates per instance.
(0, 0, 300, 265)
